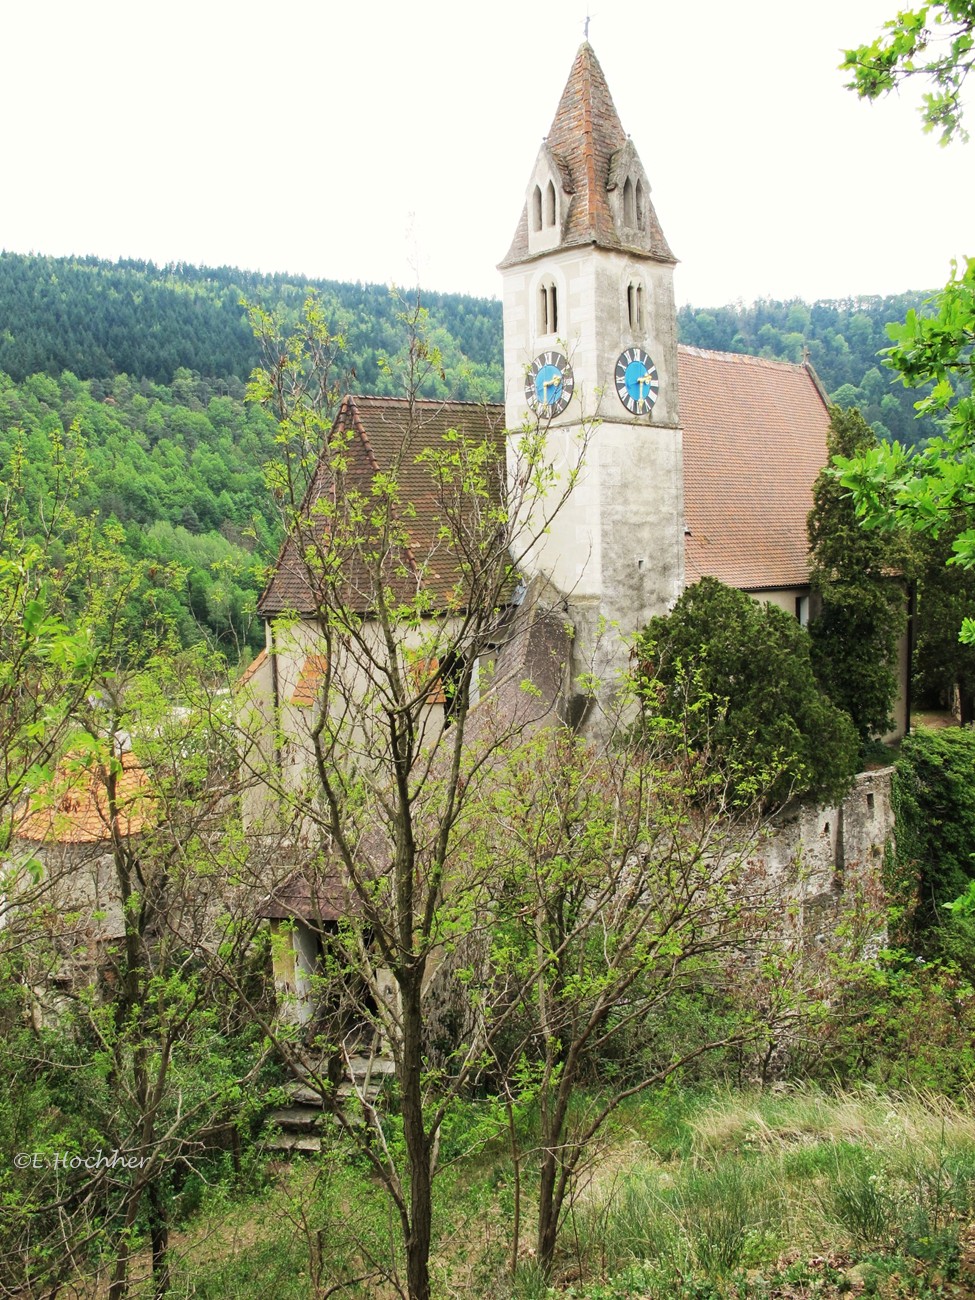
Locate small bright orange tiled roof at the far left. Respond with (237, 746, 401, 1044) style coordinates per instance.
(14, 751, 152, 844)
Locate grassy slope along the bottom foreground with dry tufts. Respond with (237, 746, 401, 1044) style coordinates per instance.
(139, 1089, 975, 1300)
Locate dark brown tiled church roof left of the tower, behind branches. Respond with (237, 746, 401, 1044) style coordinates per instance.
(257, 395, 504, 618)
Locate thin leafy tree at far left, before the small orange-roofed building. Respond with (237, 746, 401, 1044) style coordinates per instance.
(0, 655, 275, 1300)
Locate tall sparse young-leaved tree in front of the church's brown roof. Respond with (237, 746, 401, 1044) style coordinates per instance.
(226, 302, 595, 1300)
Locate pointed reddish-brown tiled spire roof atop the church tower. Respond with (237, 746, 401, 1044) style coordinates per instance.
(501, 40, 676, 267)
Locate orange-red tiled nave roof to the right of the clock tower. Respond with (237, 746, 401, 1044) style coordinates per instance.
(677, 347, 829, 590)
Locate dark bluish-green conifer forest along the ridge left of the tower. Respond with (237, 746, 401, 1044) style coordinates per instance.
(0, 252, 502, 402)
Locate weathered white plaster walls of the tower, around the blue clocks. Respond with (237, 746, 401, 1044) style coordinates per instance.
(503, 247, 684, 650)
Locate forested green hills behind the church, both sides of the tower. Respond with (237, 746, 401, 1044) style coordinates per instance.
(0, 254, 946, 654)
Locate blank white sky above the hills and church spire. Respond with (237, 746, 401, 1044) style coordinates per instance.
(0, 0, 975, 309)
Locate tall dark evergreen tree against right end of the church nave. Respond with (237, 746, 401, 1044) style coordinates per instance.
(809, 407, 907, 742)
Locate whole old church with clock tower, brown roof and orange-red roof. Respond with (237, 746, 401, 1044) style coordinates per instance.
(241, 42, 904, 1021)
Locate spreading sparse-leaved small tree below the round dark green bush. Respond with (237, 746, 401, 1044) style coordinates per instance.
(486, 733, 797, 1275)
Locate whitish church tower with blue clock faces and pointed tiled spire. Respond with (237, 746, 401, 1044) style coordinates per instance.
(499, 42, 684, 712)
